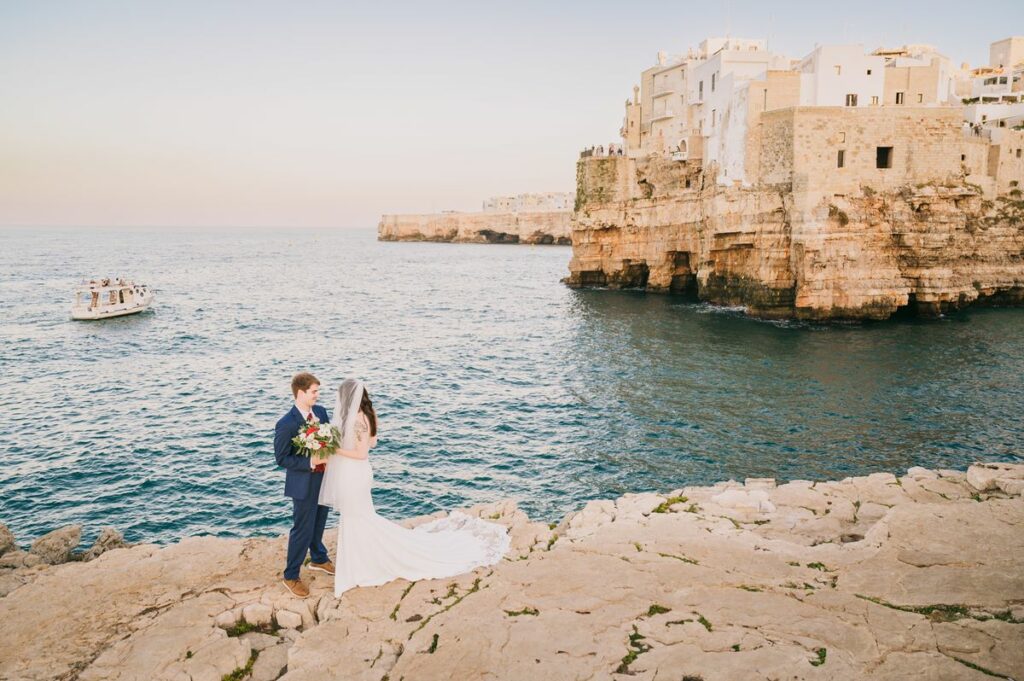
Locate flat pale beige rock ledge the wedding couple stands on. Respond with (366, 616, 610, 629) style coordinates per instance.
(0, 464, 1024, 681)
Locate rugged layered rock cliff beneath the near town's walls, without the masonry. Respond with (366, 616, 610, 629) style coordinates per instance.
(566, 159, 1024, 320)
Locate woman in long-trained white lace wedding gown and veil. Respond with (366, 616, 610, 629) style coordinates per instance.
(319, 379, 510, 597)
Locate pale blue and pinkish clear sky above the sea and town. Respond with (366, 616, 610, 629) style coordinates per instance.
(0, 0, 1024, 228)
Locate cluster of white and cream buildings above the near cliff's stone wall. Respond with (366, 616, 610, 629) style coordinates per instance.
(622, 33, 1024, 184)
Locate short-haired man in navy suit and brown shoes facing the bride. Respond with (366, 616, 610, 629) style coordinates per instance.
(273, 372, 334, 598)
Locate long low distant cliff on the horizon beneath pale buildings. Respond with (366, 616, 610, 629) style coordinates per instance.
(377, 211, 572, 246)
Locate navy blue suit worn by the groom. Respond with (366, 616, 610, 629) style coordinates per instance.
(273, 405, 330, 580)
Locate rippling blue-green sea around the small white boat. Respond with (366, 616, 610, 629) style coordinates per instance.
(0, 229, 1024, 543)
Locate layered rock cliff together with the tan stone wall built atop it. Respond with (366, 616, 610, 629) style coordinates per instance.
(565, 110, 1024, 320)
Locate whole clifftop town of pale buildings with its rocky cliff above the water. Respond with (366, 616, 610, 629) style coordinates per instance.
(566, 37, 1024, 320)
